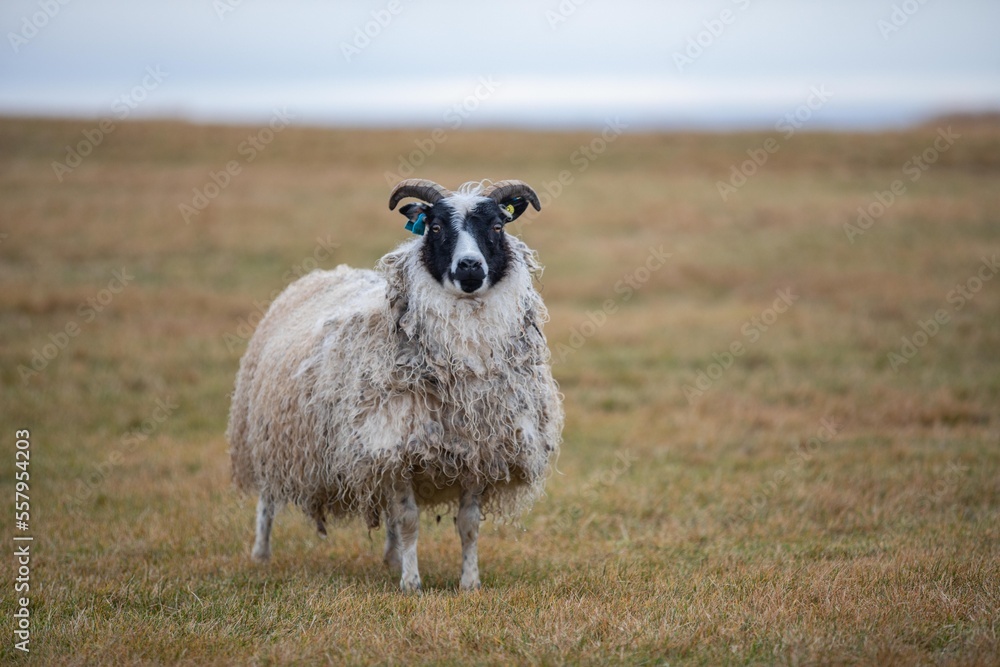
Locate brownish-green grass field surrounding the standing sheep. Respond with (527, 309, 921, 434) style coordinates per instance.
(0, 119, 1000, 665)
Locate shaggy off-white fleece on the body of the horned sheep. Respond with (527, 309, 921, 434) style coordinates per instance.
(227, 236, 563, 530)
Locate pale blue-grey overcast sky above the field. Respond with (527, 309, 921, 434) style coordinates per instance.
(0, 0, 1000, 129)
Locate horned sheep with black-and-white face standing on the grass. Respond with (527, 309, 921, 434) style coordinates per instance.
(226, 179, 563, 592)
